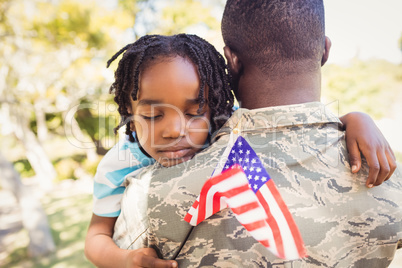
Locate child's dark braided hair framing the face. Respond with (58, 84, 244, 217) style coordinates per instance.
(107, 34, 233, 142)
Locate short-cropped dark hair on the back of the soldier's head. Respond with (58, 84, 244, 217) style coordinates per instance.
(222, 0, 327, 99)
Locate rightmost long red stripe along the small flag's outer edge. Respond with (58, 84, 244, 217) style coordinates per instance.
(267, 179, 306, 256)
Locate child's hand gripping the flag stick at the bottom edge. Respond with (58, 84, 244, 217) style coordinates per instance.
(125, 248, 178, 268)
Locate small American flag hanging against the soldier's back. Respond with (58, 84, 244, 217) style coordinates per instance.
(184, 136, 306, 260)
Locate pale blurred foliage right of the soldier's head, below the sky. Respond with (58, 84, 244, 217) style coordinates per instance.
(322, 59, 402, 119)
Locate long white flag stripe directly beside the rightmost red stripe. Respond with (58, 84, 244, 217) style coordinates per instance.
(259, 185, 299, 259)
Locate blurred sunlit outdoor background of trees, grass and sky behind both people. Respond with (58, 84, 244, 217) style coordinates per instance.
(0, 0, 402, 267)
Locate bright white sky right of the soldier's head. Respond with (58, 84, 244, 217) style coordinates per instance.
(324, 0, 402, 64)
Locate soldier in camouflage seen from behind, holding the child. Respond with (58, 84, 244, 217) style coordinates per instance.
(115, 0, 402, 267)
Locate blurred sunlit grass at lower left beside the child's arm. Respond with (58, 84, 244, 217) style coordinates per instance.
(2, 181, 94, 268)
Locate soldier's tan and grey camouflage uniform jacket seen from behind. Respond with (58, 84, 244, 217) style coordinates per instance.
(116, 102, 402, 267)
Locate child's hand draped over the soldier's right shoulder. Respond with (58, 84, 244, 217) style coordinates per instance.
(341, 112, 396, 188)
